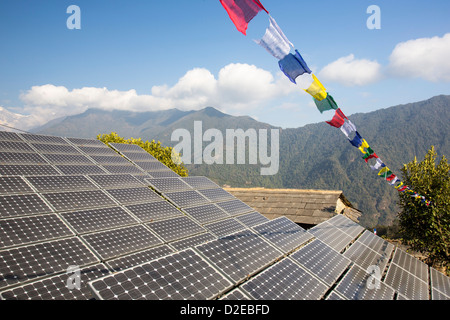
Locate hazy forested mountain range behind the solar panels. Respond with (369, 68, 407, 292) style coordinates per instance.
(22, 95, 450, 227)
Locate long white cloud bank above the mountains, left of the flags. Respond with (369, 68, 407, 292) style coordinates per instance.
(20, 64, 302, 124)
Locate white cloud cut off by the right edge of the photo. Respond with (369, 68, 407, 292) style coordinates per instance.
(390, 33, 450, 82)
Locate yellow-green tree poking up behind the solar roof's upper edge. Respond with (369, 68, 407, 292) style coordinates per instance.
(97, 132, 188, 177)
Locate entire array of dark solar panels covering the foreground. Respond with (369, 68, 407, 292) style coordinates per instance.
(0, 132, 450, 300)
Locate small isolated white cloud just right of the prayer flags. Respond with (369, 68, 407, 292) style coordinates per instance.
(319, 54, 381, 87)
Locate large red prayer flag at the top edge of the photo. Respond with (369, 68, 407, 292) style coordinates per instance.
(220, 0, 269, 35)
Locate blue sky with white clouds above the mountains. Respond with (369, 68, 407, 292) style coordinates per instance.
(0, 0, 450, 129)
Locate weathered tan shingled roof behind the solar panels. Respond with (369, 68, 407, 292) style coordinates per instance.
(225, 188, 361, 225)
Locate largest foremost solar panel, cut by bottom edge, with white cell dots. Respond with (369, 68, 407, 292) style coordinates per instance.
(89, 249, 231, 300)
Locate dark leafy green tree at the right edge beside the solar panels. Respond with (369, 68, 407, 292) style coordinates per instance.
(399, 146, 450, 268)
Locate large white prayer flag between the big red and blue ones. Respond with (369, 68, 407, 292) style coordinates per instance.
(253, 16, 294, 62)
